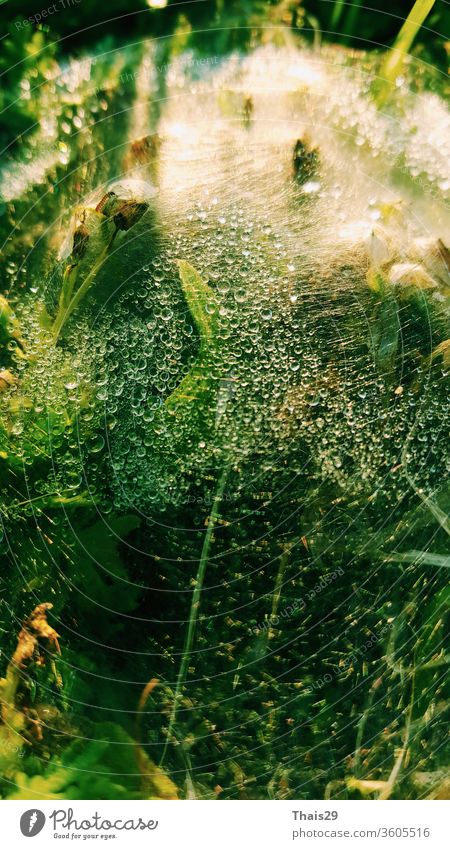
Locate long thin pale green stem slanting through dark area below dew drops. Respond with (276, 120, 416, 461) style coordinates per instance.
(160, 463, 230, 766)
